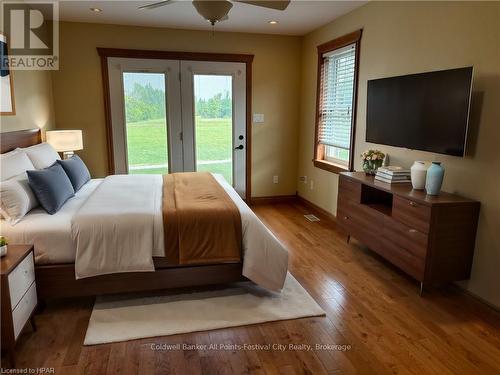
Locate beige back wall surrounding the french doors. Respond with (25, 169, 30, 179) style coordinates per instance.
(53, 22, 300, 196)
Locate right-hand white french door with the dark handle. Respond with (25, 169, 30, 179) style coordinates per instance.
(180, 61, 246, 197)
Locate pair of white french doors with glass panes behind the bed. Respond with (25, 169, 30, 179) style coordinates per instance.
(108, 58, 246, 197)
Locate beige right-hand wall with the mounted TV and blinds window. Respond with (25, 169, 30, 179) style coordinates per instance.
(298, 2, 500, 307)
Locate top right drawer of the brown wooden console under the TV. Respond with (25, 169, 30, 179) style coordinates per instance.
(392, 195, 431, 233)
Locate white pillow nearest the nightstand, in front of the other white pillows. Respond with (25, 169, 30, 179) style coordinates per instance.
(0, 172, 38, 225)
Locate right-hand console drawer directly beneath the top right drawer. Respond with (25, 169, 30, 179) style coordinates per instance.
(382, 217, 429, 259)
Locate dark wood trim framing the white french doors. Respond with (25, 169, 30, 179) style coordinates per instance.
(97, 47, 254, 202)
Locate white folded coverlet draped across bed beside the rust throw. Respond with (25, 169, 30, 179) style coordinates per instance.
(71, 175, 164, 279)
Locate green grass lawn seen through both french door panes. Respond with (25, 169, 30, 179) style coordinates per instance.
(127, 117, 233, 183)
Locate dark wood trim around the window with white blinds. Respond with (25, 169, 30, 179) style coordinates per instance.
(313, 29, 363, 173)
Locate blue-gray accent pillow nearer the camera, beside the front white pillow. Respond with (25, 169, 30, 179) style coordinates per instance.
(26, 163, 75, 215)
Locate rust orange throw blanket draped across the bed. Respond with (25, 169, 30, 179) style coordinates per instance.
(162, 172, 242, 264)
